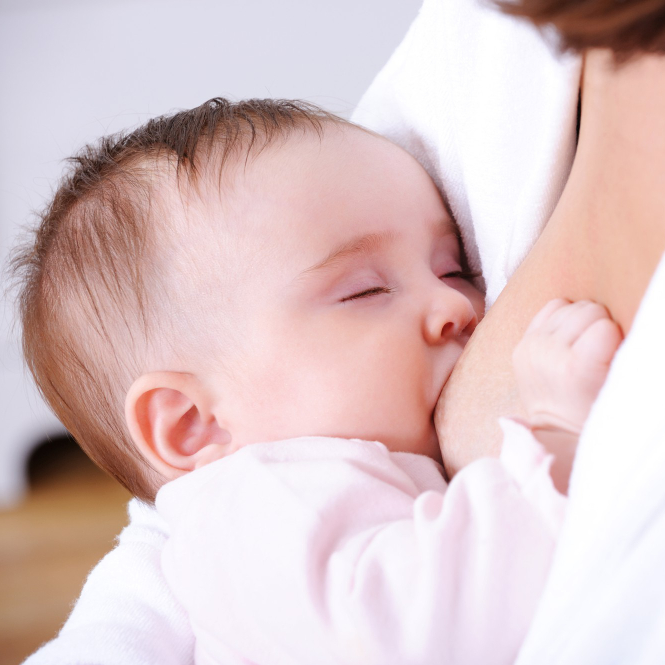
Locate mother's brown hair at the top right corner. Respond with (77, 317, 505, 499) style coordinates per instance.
(497, 0, 665, 55)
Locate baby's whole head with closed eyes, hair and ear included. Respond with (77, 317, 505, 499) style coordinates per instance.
(16, 100, 483, 500)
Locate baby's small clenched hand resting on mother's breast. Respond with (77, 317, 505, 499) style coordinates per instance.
(513, 299, 622, 434)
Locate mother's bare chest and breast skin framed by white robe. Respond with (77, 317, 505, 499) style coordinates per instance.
(435, 50, 665, 487)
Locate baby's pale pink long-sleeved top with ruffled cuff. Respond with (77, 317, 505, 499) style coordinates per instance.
(156, 421, 565, 665)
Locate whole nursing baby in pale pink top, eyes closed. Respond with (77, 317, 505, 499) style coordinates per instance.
(16, 99, 620, 665)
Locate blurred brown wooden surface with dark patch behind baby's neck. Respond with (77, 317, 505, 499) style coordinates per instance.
(0, 439, 129, 665)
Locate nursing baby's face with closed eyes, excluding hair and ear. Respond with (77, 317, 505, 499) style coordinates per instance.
(197, 127, 483, 460)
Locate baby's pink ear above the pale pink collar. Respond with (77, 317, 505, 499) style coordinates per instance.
(125, 372, 231, 480)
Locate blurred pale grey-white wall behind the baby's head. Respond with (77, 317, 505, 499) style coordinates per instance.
(0, 0, 421, 506)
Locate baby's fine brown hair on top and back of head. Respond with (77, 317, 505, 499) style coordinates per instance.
(12, 98, 344, 501)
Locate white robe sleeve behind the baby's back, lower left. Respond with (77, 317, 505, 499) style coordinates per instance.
(26, 499, 194, 665)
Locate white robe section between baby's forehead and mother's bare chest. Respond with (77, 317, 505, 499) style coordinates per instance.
(353, 0, 580, 305)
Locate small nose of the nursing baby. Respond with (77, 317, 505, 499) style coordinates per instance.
(424, 284, 478, 344)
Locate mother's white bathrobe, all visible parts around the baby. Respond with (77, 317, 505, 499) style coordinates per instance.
(22, 0, 665, 665)
